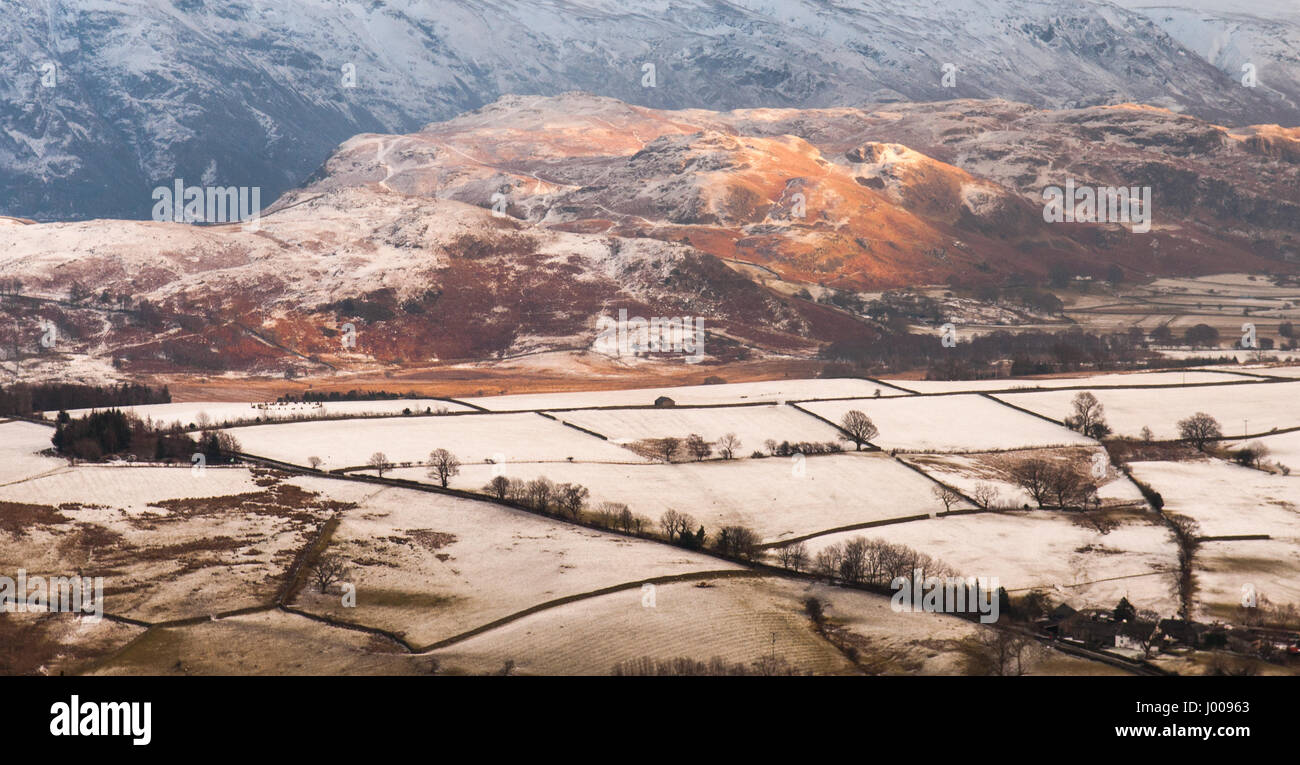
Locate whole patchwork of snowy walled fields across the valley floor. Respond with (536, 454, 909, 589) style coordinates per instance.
(0, 366, 1300, 674)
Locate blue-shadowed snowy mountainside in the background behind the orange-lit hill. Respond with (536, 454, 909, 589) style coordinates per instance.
(0, 0, 1300, 220)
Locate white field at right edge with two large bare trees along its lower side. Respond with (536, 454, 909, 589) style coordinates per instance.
(996, 383, 1300, 438)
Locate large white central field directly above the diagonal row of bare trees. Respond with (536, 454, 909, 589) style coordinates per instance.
(379, 453, 967, 541)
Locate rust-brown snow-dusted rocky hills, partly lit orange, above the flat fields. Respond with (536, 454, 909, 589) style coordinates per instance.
(0, 94, 1300, 383)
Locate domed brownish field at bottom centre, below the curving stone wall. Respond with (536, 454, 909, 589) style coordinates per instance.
(436, 578, 976, 675)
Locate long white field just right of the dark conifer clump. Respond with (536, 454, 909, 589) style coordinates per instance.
(230, 414, 641, 470)
